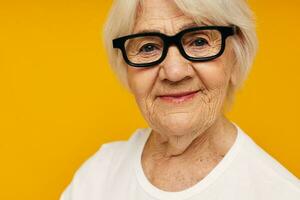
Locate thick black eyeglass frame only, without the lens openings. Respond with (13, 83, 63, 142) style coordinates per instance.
(112, 25, 238, 68)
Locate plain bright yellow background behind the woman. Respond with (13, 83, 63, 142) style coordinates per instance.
(0, 0, 300, 200)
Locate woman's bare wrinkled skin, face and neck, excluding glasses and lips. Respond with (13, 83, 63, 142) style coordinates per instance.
(127, 0, 236, 191)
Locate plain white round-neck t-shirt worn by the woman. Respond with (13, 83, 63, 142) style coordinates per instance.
(61, 123, 300, 200)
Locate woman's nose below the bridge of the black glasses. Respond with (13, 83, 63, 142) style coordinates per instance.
(159, 46, 193, 82)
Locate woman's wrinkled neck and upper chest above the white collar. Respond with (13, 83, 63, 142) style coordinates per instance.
(142, 117, 237, 191)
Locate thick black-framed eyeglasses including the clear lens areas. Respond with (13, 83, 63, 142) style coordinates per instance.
(113, 26, 237, 67)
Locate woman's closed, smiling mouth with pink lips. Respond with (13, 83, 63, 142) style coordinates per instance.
(158, 90, 200, 104)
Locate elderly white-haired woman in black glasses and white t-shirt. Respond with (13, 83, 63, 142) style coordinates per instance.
(61, 0, 300, 200)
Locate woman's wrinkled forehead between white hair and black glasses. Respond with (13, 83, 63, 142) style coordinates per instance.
(134, 0, 195, 33)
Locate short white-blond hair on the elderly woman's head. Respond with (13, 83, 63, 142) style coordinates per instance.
(103, 0, 258, 108)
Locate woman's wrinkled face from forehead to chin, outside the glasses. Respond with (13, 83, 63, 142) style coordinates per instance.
(127, 0, 235, 137)
